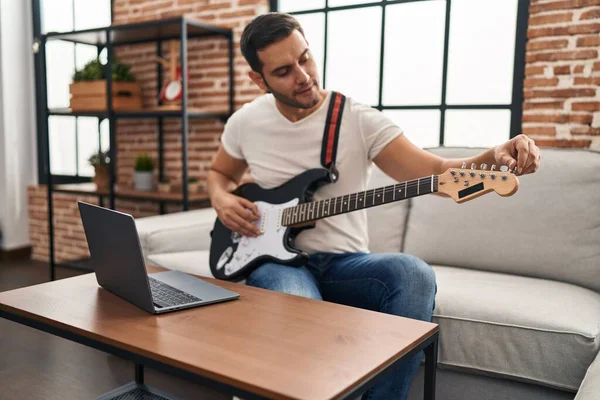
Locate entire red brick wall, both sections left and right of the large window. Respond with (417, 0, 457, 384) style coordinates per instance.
(29, 0, 600, 260)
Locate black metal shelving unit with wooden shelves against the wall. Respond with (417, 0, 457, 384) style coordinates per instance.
(34, 14, 235, 280)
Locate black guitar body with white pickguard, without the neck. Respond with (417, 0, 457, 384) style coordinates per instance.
(209, 168, 331, 281)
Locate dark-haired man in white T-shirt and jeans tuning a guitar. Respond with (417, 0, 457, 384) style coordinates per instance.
(208, 13, 540, 400)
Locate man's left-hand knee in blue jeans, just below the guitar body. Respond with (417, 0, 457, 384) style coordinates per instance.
(246, 263, 322, 300)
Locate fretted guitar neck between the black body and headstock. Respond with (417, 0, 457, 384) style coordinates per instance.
(282, 175, 438, 226)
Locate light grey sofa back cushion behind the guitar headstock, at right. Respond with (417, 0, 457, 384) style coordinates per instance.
(403, 148, 600, 292)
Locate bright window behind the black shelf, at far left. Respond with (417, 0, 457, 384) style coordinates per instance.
(33, 0, 112, 183)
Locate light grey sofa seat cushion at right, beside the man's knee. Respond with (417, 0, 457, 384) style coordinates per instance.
(434, 266, 600, 391)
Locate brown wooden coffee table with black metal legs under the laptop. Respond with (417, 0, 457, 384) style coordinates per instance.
(0, 267, 438, 400)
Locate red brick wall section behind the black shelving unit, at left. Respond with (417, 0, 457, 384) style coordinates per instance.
(28, 0, 268, 261)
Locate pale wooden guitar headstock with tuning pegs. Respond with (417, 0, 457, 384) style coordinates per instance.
(438, 163, 519, 203)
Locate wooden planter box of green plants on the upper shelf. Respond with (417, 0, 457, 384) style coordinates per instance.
(69, 58, 143, 111)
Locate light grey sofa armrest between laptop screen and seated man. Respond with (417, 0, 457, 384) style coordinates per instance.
(135, 208, 217, 261)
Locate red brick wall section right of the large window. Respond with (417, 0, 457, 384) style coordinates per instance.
(523, 0, 600, 149)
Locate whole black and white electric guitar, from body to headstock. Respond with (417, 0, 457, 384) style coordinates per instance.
(209, 163, 519, 281)
